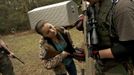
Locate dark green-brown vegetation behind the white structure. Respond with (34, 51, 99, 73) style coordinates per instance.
(0, 0, 79, 34)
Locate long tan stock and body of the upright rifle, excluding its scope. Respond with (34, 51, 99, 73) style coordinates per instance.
(82, 0, 95, 75)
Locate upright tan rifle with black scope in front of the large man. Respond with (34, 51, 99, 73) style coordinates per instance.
(82, 0, 98, 75)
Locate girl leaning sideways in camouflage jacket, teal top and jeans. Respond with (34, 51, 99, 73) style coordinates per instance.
(35, 20, 77, 75)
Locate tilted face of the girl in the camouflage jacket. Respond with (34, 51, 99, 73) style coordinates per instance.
(42, 23, 57, 38)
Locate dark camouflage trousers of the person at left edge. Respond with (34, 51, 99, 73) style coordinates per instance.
(0, 54, 15, 75)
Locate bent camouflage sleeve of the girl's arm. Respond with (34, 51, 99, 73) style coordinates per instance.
(39, 37, 66, 69)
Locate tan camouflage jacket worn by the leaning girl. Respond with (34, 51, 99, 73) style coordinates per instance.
(40, 29, 72, 69)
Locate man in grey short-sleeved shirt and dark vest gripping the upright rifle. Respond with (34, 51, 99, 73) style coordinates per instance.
(77, 0, 134, 74)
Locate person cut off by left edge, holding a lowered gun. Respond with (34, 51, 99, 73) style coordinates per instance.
(0, 39, 15, 75)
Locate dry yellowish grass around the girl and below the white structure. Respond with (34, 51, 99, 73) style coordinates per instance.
(2, 29, 83, 75)
